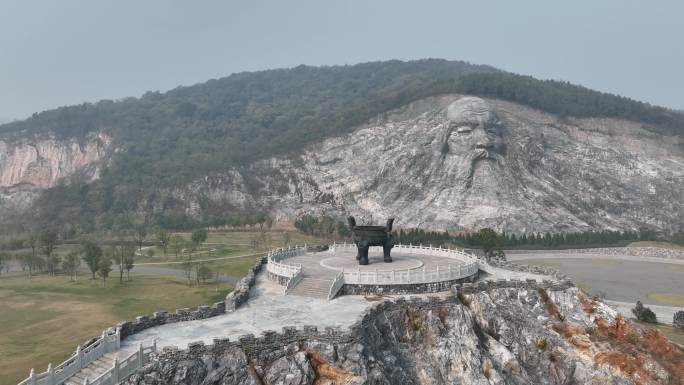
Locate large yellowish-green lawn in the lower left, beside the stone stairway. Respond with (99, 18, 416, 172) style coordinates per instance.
(0, 274, 232, 384)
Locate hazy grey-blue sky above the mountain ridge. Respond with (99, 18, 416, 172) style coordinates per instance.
(0, 0, 684, 118)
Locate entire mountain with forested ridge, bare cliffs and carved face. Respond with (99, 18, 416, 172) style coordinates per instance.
(0, 60, 684, 232)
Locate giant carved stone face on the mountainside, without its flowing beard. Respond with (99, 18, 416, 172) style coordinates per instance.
(446, 96, 502, 164)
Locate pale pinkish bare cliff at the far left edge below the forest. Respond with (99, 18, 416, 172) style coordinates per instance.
(0, 133, 111, 210)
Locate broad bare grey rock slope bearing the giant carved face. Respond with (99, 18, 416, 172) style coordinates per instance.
(180, 95, 684, 232)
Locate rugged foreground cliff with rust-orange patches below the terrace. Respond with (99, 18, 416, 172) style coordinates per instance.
(120, 287, 684, 385)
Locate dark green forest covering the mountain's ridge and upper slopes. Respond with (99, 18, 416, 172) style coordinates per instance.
(0, 60, 684, 234)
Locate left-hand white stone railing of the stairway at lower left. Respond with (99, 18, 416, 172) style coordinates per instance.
(19, 328, 121, 385)
